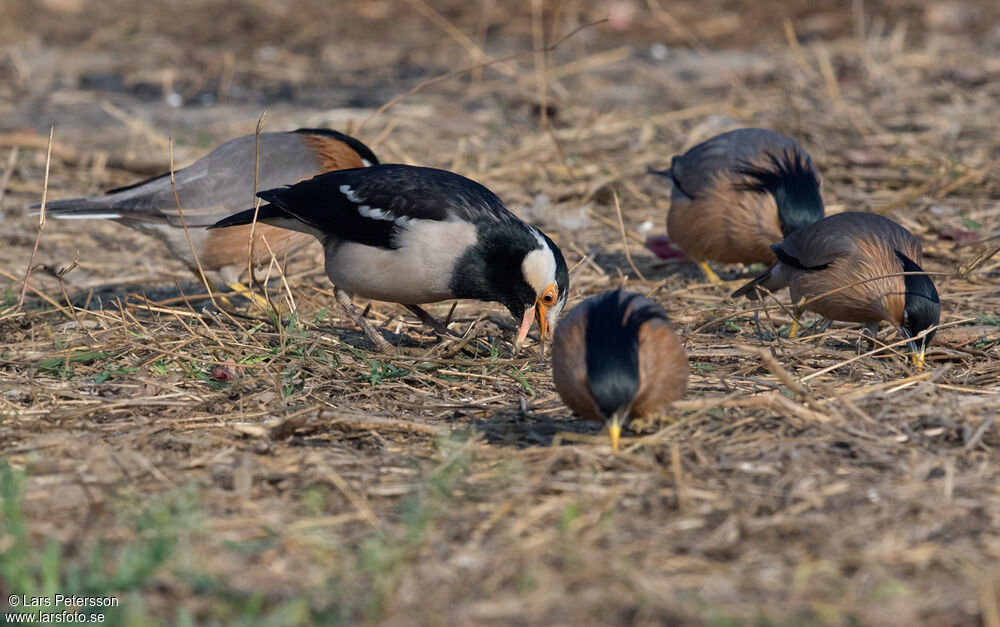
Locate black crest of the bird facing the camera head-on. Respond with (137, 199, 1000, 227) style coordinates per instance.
(586, 289, 666, 419)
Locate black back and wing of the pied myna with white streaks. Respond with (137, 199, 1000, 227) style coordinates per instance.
(215, 164, 520, 249)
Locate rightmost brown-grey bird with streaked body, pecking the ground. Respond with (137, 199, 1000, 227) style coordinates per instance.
(733, 212, 941, 368)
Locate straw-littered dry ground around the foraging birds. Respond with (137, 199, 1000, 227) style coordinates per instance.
(0, 0, 1000, 627)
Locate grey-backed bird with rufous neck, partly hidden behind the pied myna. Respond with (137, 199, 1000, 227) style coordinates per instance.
(34, 128, 378, 302)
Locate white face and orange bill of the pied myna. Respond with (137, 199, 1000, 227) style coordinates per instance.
(508, 230, 569, 351)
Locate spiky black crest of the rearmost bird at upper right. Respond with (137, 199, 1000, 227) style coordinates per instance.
(737, 151, 823, 237)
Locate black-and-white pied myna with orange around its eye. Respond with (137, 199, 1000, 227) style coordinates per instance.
(212, 164, 569, 350)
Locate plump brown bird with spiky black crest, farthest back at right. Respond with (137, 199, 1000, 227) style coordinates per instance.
(647, 128, 823, 283)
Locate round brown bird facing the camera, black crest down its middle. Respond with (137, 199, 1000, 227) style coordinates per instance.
(552, 289, 688, 449)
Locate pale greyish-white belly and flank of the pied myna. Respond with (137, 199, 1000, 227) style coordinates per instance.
(326, 220, 477, 305)
